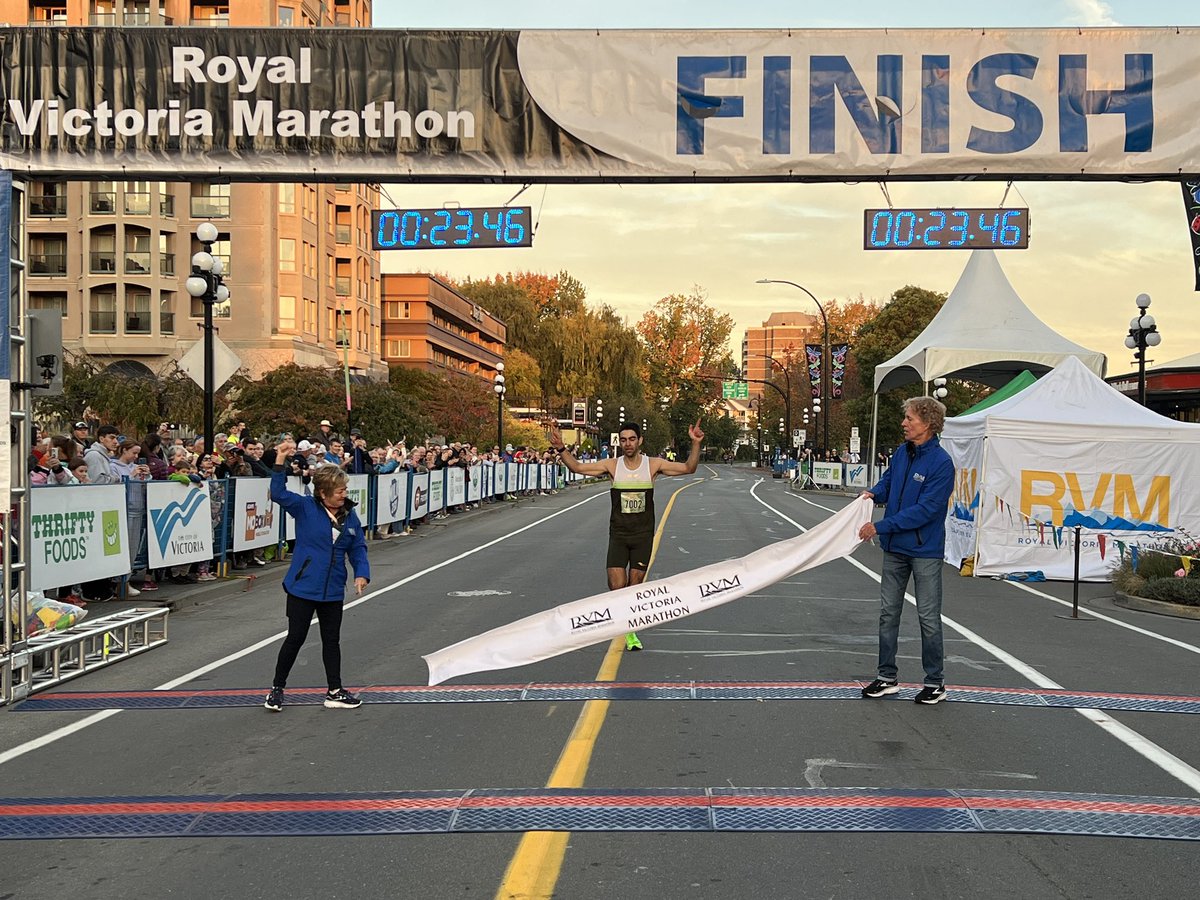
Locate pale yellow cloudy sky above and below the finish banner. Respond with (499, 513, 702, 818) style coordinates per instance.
(374, 0, 1200, 374)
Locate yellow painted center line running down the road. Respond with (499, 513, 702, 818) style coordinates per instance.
(496, 479, 703, 900)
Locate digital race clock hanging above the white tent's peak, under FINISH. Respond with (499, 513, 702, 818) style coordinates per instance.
(863, 208, 1030, 250)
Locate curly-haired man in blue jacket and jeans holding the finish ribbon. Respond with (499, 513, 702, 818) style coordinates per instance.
(858, 397, 954, 706)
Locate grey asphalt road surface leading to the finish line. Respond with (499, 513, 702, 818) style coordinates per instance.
(0, 466, 1200, 900)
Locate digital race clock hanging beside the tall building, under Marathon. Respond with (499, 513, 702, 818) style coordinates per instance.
(371, 206, 533, 250)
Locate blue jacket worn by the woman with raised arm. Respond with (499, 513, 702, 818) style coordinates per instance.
(271, 470, 371, 601)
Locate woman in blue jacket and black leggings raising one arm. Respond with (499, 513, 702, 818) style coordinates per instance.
(263, 461, 371, 713)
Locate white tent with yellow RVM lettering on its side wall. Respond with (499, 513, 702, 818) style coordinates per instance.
(942, 358, 1200, 581)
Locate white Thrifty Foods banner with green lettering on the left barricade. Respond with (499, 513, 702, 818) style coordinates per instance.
(29, 485, 132, 590)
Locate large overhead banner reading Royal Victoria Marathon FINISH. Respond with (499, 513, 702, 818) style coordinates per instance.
(0, 28, 1200, 181)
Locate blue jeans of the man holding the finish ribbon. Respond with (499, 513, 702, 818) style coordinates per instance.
(878, 552, 943, 688)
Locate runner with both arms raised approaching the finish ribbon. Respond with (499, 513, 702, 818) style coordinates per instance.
(550, 419, 704, 650)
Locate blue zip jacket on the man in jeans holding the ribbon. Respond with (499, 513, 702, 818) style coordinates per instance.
(871, 434, 954, 559)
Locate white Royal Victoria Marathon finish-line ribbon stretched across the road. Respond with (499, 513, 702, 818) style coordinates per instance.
(422, 497, 874, 685)
